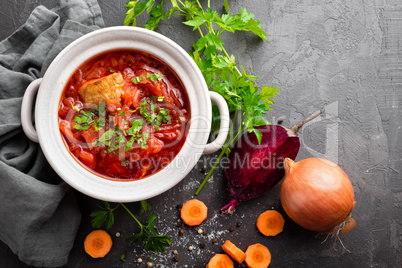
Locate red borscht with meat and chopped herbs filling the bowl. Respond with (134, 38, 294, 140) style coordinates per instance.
(59, 50, 190, 180)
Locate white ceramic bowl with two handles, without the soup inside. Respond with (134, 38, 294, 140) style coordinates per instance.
(21, 27, 229, 202)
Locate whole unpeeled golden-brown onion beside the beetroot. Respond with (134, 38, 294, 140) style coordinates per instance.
(280, 158, 356, 233)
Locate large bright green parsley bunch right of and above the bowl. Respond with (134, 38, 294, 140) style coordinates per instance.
(124, 0, 278, 194)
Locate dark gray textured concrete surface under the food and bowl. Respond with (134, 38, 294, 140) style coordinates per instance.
(0, 0, 402, 267)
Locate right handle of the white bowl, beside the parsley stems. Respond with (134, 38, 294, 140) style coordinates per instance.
(203, 91, 230, 154)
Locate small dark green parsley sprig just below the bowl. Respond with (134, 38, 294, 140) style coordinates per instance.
(90, 200, 172, 254)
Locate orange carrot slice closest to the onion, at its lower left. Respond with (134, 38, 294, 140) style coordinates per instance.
(257, 210, 285, 236)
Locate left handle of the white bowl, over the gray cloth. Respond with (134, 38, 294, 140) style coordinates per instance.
(21, 78, 42, 142)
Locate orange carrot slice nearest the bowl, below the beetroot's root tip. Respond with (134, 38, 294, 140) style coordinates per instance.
(180, 199, 208, 226)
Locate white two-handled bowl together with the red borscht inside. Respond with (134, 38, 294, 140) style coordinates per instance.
(21, 26, 229, 202)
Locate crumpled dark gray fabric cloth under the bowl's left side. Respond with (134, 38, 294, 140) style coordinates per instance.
(0, 0, 104, 267)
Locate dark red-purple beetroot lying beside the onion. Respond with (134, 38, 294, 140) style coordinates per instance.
(221, 111, 321, 213)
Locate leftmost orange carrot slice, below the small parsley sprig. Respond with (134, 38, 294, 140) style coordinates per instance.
(84, 230, 113, 258)
